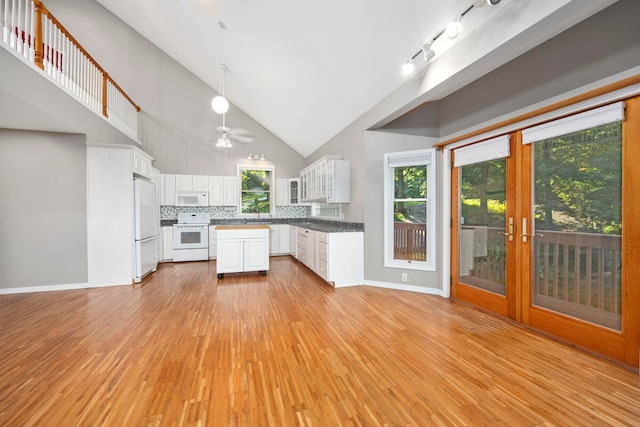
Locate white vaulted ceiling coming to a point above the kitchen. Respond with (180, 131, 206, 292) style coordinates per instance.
(97, 0, 611, 157)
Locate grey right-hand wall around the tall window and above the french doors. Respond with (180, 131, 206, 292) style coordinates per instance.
(309, 0, 640, 287)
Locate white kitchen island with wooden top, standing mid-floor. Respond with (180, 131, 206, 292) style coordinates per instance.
(216, 226, 270, 279)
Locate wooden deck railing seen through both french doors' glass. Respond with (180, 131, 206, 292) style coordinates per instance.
(460, 226, 622, 328)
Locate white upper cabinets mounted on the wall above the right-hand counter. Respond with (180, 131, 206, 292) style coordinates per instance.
(300, 156, 351, 203)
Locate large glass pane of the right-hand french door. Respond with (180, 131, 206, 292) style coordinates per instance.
(532, 122, 622, 330)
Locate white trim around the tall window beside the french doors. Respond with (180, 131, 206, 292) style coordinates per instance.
(384, 148, 437, 271)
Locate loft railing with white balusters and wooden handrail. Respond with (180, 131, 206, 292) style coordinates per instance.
(0, 0, 140, 139)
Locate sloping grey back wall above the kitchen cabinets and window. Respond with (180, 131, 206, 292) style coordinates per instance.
(46, 0, 305, 177)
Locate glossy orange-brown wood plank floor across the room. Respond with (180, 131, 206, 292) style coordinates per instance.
(0, 257, 640, 426)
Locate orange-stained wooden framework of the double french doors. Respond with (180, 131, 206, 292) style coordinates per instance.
(450, 96, 640, 367)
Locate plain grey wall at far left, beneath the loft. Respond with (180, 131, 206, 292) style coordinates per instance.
(0, 129, 87, 289)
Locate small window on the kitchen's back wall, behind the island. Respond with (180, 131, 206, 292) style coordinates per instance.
(238, 165, 274, 217)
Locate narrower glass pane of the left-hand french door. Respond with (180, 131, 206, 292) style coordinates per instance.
(459, 159, 507, 295)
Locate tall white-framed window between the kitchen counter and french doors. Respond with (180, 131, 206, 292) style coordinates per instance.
(384, 148, 436, 271)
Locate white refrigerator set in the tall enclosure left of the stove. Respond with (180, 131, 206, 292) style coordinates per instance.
(133, 178, 159, 282)
